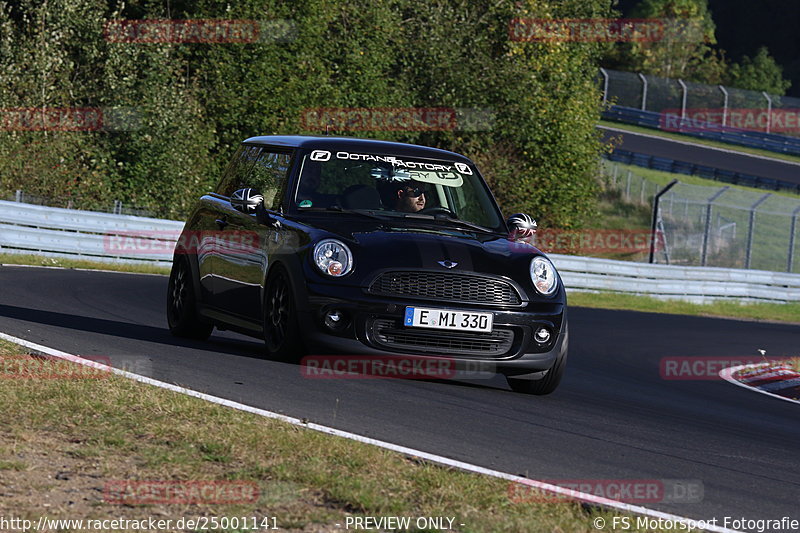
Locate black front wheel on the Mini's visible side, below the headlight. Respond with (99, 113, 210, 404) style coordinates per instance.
(264, 267, 305, 362)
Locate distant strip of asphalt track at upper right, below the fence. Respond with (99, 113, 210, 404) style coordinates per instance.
(598, 126, 800, 183)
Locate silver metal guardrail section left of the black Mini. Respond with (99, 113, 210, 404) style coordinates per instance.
(0, 201, 183, 267)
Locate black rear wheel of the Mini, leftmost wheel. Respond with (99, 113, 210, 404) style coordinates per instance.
(167, 256, 214, 340)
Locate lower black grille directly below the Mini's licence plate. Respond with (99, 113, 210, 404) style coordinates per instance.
(372, 318, 514, 357)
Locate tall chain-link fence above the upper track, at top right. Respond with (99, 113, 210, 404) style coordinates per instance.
(600, 69, 800, 136)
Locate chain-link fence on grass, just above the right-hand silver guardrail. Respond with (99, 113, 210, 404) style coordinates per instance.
(602, 161, 800, 273)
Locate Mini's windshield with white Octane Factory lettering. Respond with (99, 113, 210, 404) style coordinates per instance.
(294, 150, 503, 231)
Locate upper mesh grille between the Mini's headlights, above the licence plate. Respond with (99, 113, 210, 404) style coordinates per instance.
(369, 271, 522, 305)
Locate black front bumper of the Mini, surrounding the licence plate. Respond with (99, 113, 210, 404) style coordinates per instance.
(298, 283, 567, 375)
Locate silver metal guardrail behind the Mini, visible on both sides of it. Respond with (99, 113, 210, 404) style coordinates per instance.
(0, 201, 800, 303)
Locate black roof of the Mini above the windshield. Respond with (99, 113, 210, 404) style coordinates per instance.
(243, 135, 472, 163)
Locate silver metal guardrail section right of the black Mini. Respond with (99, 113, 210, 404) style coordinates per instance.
(548, 254, 800, 303)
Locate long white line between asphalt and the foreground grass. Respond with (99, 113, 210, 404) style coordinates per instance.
(0, 333, 737, 533)
